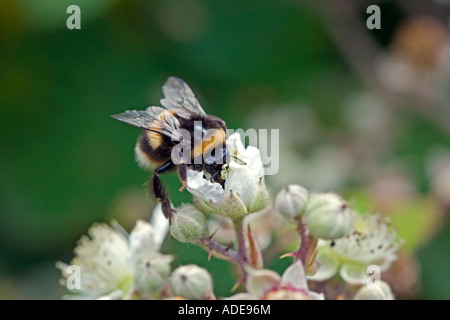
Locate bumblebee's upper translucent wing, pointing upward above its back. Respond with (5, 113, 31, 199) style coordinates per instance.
(161, 77, 206, 118)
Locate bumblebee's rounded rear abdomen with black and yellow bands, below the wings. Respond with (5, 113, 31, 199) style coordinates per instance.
(135, 131, 172, 169)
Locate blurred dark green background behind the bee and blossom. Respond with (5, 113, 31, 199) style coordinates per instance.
(0, 0, 450, 299)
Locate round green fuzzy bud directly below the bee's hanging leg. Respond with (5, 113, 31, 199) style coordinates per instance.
(170, 204, 206, 243)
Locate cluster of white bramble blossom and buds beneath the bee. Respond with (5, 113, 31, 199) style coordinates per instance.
(57, 134, 400, 300)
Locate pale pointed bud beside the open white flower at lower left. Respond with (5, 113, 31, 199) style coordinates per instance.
(134, 254, 173, 296)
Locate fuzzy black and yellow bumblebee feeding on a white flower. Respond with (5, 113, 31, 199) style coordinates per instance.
(112, 77, 244, 218)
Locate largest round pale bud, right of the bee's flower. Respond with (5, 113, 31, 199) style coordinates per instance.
(304, 193, 353, 239)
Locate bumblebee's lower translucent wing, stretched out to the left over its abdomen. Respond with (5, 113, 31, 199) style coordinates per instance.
(111, 107, 183, 141)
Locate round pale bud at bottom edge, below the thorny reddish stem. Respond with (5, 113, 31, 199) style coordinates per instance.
(169, 264, 213, 299)
